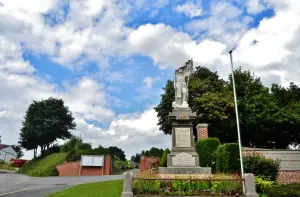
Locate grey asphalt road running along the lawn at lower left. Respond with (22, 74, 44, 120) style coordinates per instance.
(0, 171, 123, 197)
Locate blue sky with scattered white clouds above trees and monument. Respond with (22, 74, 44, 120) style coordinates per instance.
(0, 0, 300, 158)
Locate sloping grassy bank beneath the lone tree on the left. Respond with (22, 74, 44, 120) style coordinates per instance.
(20, 153, 66, 176)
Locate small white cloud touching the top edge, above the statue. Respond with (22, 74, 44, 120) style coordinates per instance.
(174, 1, 203, 18)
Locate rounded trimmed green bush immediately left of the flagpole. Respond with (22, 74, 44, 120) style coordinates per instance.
(216, 143, 241, 173)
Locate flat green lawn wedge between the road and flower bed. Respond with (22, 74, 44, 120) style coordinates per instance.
(47, 180, 123, 197)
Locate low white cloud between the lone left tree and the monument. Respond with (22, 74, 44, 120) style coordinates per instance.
(76, 109, 171, 159)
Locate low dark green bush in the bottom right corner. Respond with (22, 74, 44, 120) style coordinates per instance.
(264, 184, 300, 197)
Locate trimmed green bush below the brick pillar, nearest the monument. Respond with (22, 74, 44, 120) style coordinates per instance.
(196, 138, 220, 172)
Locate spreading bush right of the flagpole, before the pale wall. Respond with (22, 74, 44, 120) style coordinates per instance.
(243, 155, 280, 181)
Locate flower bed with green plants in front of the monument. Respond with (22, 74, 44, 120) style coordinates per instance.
(133, 172, 242, 196)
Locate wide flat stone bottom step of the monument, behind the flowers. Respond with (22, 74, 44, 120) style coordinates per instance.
(159, 166, 211, 174)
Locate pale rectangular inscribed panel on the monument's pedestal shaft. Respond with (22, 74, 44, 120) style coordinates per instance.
(175, 128, 191, 148)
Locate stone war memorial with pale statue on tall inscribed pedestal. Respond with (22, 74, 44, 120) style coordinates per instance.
(159, 60, 211, 174)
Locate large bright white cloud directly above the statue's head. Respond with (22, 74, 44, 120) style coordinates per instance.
(129, 24, 226, 68)
